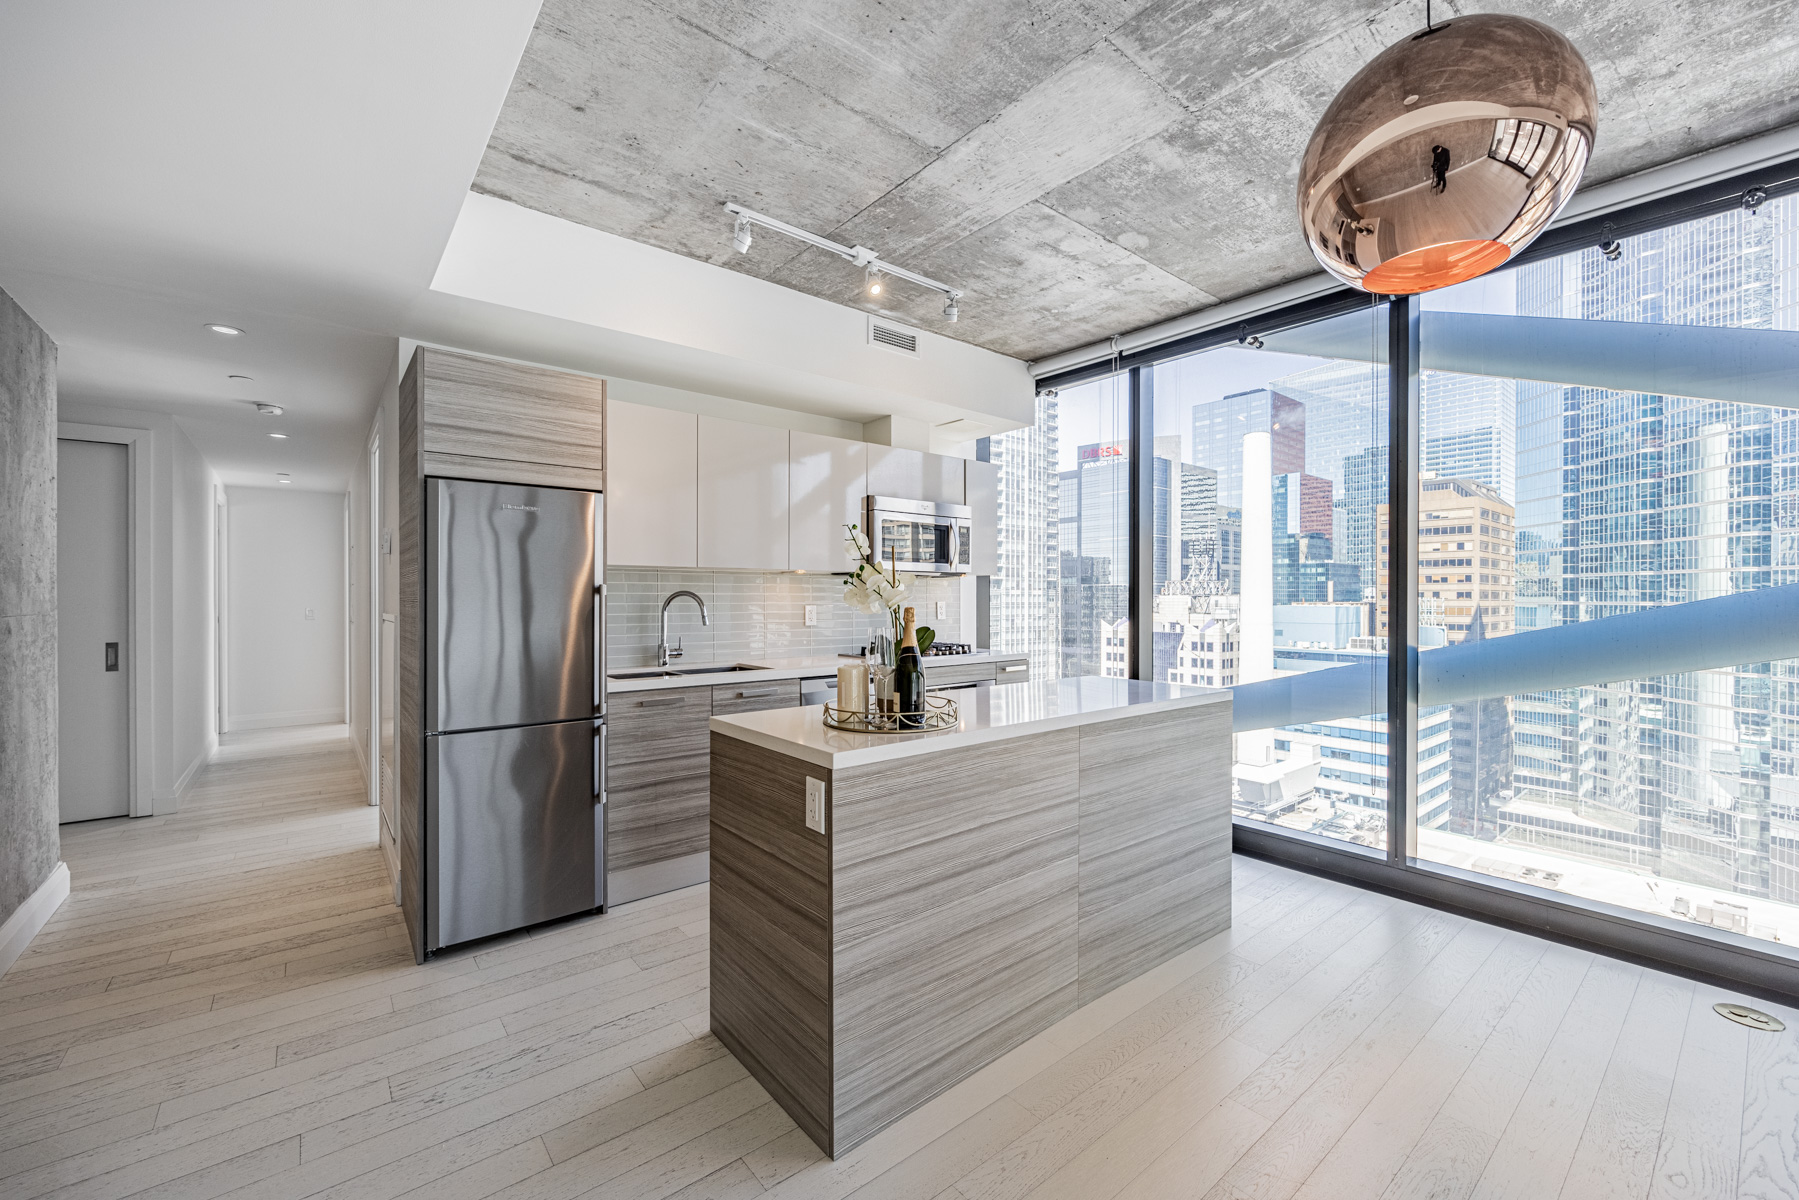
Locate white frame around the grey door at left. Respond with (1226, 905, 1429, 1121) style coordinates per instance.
(56, 421, 157, 817)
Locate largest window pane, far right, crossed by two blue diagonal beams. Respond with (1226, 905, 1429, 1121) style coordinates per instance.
(1396, 196, 1799, 941)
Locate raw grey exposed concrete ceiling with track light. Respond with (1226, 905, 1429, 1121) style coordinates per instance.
(475, 0, 1799, 358)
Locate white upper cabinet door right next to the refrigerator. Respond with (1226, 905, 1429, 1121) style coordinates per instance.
(606, 399, 700, 567)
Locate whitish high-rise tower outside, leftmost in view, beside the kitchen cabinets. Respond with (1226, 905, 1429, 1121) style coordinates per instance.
(989, 392, 1061, 678)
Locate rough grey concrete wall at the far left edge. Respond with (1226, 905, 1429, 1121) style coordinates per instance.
(0, 291, 61, 923)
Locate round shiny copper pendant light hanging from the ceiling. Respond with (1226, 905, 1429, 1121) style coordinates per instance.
(1299, 14, 1598, 295)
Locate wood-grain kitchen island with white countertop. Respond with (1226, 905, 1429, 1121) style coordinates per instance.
(711, 678, 1231, 1157)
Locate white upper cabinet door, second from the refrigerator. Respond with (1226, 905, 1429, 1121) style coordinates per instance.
(700, 417, 788, 570)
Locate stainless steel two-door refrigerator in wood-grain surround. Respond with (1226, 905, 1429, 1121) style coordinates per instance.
(425, 479, 606, 954)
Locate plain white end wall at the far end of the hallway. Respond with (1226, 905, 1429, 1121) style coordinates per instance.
(225, 488, 345, 730)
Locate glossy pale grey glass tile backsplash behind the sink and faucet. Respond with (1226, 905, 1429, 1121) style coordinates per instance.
(606, 567, 968, 671)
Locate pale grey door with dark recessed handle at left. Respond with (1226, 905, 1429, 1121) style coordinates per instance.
(56, 439, 131, 822)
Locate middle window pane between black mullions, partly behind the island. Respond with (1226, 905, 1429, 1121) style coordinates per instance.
(1150, 309, 1389, 847)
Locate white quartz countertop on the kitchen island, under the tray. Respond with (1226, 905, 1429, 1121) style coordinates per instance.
(712, 675, 1231, 770)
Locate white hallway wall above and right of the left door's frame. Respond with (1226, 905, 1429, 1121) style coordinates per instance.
(56, 399, 218, 813)
